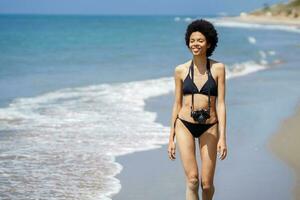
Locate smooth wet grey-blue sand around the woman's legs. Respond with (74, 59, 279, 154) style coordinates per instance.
(112, 61, 299, 200)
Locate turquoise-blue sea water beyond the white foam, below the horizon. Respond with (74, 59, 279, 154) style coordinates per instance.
(0, 15, 295, 105)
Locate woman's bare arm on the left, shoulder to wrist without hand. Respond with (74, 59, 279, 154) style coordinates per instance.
(169, 66, 182, 142)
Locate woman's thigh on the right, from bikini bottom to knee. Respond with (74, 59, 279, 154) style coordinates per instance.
(198, 124, 218, 183)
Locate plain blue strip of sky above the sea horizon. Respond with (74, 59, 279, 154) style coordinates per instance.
(0, 0, 287, 15)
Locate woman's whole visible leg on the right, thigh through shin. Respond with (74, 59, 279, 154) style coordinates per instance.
(199, 124, 218, 200)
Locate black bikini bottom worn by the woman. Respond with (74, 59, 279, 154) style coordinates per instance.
(174, 116, 218, 138)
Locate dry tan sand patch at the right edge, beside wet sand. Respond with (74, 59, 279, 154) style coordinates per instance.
(267, 103, 300, 200)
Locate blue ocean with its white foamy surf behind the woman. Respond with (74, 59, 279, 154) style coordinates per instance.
(0, 15, 300, 200)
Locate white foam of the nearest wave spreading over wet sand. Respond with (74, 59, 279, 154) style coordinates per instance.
(0, 61, 267, 200)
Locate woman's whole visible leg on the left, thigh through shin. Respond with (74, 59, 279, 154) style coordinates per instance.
(175, 119, 199, 200)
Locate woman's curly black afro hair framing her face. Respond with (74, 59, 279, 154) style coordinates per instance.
(185, 19, 218, 57)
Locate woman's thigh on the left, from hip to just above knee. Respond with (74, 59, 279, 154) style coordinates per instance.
(175, 119, 198, 177)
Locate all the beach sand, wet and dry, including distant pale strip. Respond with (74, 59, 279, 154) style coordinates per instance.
(112, 17, 300, 200)
